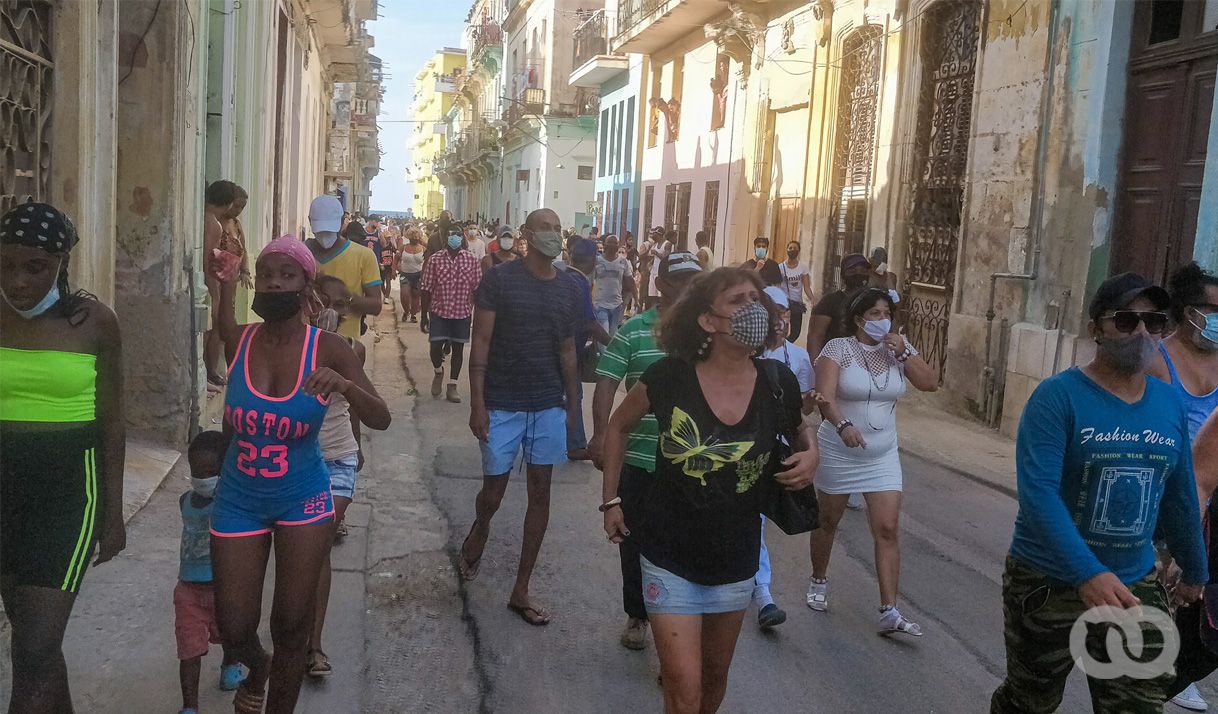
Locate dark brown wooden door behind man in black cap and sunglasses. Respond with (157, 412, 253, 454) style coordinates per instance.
(1111, 2, 1218, 277)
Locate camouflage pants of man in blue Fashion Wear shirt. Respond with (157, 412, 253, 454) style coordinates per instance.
(990, 558, 1175, 714)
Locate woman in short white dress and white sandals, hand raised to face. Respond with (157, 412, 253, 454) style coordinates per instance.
(808, 288, 939, 636)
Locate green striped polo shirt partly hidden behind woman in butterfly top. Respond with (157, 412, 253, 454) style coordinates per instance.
(597, 307, 664, 473)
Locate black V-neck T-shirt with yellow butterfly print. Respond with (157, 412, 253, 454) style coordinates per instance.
(631, 357, 800, 585)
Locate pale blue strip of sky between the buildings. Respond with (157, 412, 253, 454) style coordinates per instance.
(369, 0, 471, 211)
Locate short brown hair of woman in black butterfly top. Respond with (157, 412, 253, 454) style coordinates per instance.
(657, 268, 783, 364)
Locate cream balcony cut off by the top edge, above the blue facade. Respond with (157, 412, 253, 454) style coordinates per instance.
(610, 0, 727, 55)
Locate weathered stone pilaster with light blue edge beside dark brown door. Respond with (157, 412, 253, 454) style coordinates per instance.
(994, 0, 1133, 435)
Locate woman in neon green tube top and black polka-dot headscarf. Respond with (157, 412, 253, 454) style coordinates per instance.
(0, 202, 127, 714)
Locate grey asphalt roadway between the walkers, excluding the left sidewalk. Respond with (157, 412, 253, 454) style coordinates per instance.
(369, 317, 1198, 714)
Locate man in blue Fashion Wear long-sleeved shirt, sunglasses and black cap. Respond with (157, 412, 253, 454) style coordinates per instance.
(990, 273, 1208, 714)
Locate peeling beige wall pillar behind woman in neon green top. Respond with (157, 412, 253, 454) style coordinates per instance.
(114, 0, 206, 447)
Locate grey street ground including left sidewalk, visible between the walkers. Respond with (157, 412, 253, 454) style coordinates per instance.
(0, 303, 1218, 714)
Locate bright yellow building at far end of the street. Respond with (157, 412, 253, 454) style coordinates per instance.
(410, 48, 465, 217)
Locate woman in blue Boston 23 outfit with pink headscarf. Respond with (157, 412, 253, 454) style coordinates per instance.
(211, 236, 390, 714)
